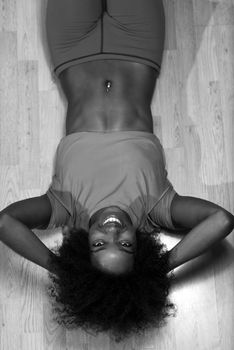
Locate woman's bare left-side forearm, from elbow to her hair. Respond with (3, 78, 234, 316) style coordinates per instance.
(0, 214, 54, 273)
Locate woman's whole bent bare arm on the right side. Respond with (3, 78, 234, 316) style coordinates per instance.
(169, 195, 234, 271)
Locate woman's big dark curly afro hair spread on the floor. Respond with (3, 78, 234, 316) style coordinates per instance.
(48, 229, 176, 341)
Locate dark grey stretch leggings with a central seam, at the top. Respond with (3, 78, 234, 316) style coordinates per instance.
(46, 0, 165, 76)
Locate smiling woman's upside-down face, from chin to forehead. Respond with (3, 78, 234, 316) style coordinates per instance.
(89, 206, 136, 274)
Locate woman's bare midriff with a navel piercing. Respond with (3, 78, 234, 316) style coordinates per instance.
(59, 60, 158, 135)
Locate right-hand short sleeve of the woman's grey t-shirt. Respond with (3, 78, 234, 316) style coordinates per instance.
(148, 185, 176, 230)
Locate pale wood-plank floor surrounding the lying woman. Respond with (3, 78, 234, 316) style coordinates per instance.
(0, 0, 234, 350)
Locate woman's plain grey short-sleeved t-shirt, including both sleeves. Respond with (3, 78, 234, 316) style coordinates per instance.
(47, 131, 176, 230)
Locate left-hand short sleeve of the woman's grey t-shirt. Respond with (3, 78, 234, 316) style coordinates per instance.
(46, 189, 72, 230)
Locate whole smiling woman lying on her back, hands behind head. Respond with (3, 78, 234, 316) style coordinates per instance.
(0, 0, 234, 339)
